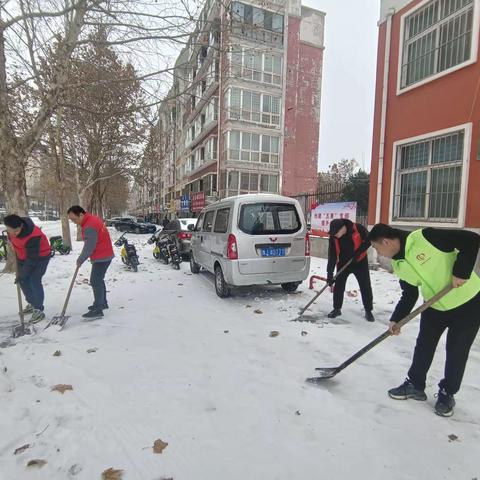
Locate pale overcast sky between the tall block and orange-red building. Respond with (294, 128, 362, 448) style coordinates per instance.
(302, 0, 380, 171)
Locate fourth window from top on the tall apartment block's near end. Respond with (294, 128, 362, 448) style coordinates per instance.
(224, 130, 280, 165)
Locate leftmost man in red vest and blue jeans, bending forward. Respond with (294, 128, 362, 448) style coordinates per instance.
(4, 215, 50, 323)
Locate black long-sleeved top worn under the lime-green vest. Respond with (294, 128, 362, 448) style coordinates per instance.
(390, 228, 480, 322)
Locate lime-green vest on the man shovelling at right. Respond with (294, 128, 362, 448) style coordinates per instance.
(392, 230, 480, 311)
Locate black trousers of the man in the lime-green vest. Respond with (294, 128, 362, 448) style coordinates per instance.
(408, 294, 480, 395)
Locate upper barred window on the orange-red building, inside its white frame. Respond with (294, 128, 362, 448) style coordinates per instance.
(400, 0, 474, 88)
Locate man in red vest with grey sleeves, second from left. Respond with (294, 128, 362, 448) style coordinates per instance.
(68, 205, 114, 319)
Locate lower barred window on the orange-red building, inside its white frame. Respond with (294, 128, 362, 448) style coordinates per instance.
(393, 130, 465, 222)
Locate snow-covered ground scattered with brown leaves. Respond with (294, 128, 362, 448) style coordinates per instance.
(0, 222, 480, 480)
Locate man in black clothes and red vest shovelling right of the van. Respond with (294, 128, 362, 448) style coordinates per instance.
(327, 218, 375, 322)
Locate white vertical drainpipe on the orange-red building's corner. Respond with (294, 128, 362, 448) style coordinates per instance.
(375, 9, 395, 223)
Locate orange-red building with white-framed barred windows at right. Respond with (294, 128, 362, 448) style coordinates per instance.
(369, 0, 480, 230)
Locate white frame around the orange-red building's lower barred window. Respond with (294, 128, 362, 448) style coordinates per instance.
(388, 123, 472, 228)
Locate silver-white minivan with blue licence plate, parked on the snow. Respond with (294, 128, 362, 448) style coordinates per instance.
(190, 194, 310, 298)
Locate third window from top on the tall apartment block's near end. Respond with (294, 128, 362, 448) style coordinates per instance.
(225, 87, 280, 128)
